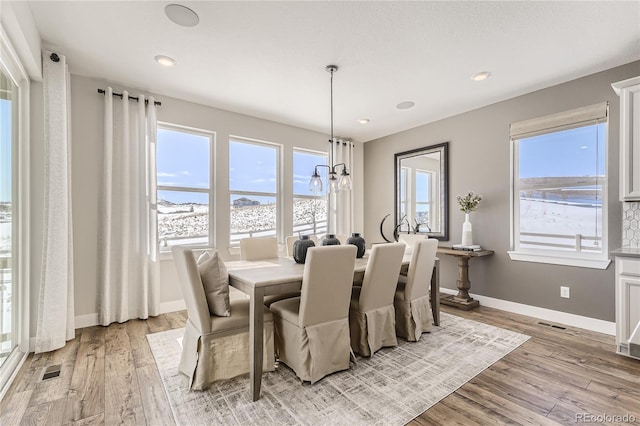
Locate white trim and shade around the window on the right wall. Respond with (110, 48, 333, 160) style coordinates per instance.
(507, 102, 611, 269)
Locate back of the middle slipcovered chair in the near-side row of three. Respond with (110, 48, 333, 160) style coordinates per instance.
(359, 243, 405, 312)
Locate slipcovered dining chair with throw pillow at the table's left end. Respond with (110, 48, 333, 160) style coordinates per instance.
(171, 246, 275, 390)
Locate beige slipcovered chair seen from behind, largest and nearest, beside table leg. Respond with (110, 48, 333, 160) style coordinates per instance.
(271, 245, 357, 383)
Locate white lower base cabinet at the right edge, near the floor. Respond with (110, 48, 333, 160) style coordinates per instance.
(616, 256, 640, 359)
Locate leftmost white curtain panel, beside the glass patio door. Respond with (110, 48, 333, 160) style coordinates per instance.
(35, 51, 75, 353)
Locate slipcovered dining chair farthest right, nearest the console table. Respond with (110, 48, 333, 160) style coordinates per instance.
(393, 238, 438, 342)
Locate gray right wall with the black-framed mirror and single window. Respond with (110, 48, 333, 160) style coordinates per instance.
(364, 62, 640, 321)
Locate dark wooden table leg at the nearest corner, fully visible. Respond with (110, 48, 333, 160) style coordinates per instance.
(249, 288, 264, 401)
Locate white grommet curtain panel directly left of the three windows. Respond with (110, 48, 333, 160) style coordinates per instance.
(98, 87, 160, 325)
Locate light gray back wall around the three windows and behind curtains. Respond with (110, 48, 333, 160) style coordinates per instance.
(30, 75, 363, 336)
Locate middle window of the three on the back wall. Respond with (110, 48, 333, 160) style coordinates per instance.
(229, 138, 280, 247)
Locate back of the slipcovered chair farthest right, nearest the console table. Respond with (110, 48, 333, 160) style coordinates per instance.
(404, 238, 438, 300)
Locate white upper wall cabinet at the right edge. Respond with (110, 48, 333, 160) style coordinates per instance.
(611, 77, 640, 201)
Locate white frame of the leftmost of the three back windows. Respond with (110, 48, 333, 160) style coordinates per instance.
(155, 121, 216, 251)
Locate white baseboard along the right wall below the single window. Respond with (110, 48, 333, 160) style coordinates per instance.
(440, 287, 616, 336)
